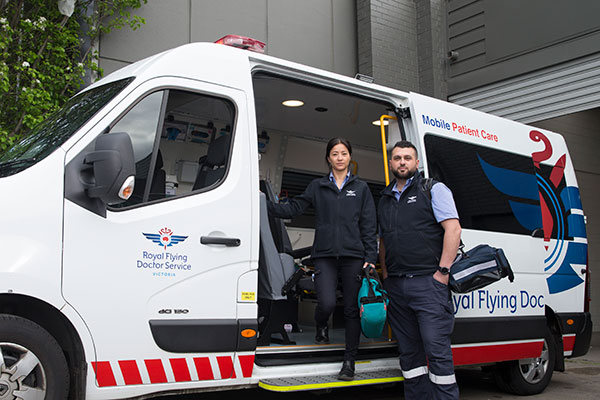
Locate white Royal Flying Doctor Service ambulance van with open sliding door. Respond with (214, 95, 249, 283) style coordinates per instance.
(0, 37, 592, 399)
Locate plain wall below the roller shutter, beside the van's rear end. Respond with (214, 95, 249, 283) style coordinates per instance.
(532, 108, 600, 331)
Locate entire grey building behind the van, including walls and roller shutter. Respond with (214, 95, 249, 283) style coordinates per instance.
(99, 0, 600, 330)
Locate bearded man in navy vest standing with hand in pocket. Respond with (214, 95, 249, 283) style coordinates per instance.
(378, 141, 461, 400)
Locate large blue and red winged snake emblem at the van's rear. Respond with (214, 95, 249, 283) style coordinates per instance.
(478, 130, 587, 294)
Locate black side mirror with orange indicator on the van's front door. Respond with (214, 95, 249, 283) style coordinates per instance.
(83, 132, 135, 204)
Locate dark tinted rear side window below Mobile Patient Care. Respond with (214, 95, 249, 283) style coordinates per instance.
(425, 135, 542, 235)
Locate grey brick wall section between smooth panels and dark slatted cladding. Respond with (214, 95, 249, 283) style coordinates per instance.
(356, 0, 447, 99)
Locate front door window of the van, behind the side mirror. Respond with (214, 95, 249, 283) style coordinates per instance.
(110, 90, 235, 208)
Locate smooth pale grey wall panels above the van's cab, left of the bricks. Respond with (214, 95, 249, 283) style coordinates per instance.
(99, 0, 358, 76)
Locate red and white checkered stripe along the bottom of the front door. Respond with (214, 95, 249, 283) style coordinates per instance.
(91, 354, 254, 387)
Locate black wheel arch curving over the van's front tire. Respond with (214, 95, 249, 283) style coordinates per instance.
(0, 294, 87, 399)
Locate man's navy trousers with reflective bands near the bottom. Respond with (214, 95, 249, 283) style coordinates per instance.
(384, 275, 458, 400)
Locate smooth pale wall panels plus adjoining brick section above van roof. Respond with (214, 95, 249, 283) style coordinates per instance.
(99, 0, 447, 99)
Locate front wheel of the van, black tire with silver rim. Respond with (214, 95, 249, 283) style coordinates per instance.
(0, 314, 69, 400)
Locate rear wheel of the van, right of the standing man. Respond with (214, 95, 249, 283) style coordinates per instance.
(493, 330, 556, 396)
